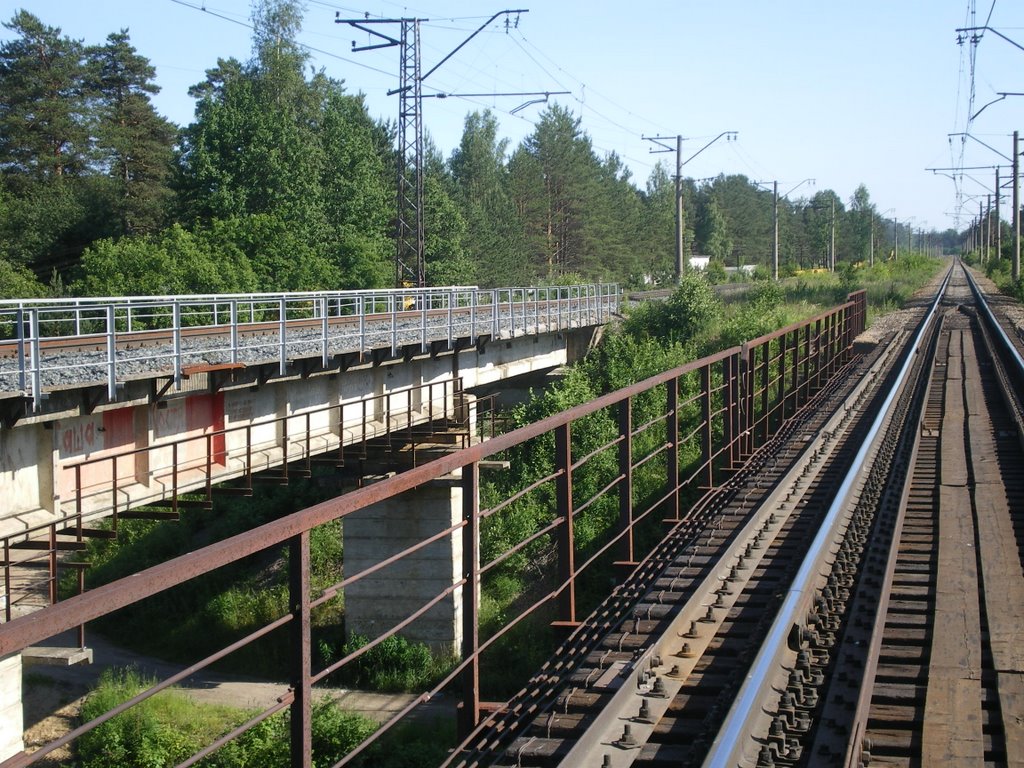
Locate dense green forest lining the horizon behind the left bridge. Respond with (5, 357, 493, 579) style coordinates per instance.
(0, 0, 956, 298)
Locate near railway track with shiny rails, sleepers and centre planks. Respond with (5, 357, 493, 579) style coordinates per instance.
(449, 260, 1024, 768)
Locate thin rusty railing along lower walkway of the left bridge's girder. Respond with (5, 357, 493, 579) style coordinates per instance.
(0, 378, 471, 630)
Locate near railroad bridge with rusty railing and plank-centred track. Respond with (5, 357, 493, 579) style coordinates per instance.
(0, 262, 1024, 768)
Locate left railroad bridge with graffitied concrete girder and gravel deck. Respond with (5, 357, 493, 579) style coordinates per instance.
(0, 285, 620, 756)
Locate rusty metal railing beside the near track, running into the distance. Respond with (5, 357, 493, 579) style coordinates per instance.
(0, 295, 864, 768)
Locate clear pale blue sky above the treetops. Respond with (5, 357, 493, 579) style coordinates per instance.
(0, 0, 1024, 229)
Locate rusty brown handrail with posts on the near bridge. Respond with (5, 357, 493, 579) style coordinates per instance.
(0, 286, 857, 766)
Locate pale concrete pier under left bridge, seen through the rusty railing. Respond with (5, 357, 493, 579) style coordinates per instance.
(342, 476, 463, 651)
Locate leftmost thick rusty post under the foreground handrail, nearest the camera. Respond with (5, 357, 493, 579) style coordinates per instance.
(288, 529, 312, 768)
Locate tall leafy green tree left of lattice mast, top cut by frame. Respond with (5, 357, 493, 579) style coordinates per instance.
(180, 0, 393, 290)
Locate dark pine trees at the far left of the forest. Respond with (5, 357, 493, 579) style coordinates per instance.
(0, 10, 176, 274)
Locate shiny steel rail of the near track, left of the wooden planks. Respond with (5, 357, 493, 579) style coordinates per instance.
(703, 267, 952, 768)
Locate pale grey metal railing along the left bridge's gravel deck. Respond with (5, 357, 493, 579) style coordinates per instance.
(0, 284, 620, 410)
